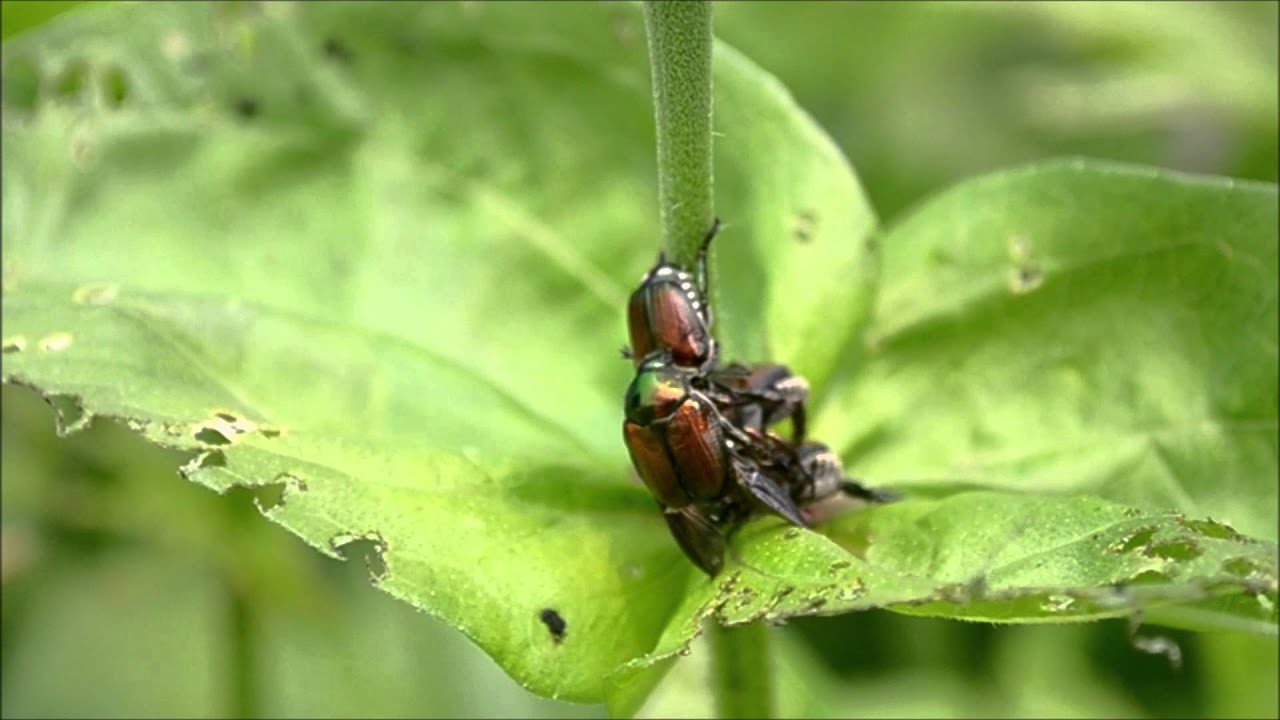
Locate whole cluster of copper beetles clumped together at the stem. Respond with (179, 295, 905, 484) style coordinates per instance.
(622, 215, 887, 575)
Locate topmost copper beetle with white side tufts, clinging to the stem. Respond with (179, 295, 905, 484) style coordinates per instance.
(622, 219, 719, 369)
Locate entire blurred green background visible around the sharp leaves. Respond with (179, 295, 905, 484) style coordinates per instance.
(0, 1, 1280, 717)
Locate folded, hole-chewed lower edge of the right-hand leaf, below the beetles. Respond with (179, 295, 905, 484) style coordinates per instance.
(607, 492, 1280, 715)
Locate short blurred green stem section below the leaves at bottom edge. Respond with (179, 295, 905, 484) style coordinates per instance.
(707, 620, 777, 717)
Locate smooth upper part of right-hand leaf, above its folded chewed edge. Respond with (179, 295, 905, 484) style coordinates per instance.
(814, 156, 1280, 538)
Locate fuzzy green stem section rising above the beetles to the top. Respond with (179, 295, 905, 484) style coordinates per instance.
(644, 0, 714, 268)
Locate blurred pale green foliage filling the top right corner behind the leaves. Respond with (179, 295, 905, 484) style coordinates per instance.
(716, 1, 1277, 218)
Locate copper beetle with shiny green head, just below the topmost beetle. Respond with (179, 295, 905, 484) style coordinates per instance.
(622, 354, 806, 575)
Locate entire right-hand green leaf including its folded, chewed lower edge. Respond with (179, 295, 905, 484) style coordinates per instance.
(608, 161, 1280, 714)
